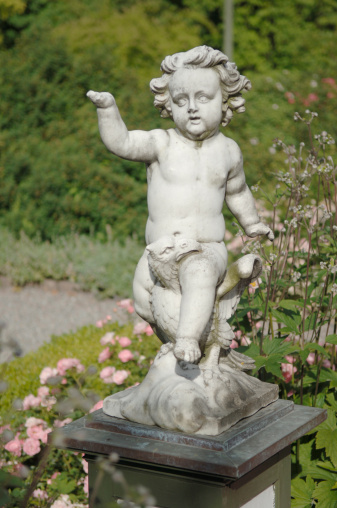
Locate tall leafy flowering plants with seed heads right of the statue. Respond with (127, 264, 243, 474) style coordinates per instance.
(232, 111, 337, 508)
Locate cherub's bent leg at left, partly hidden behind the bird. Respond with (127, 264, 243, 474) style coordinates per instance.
(133, 250, 154, 323)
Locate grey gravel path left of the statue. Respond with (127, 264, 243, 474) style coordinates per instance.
(0, 278, 134, 363)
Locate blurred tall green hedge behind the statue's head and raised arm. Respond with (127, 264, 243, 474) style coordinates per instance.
(0, 0, 337, 239)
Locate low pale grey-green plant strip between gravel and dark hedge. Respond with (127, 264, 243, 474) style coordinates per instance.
(0, 228, 144, 297)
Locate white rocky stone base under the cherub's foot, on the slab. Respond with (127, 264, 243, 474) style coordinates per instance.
(103, 351, 279, 436)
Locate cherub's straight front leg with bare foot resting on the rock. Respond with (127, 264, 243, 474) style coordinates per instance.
(174, 244, 227, 363)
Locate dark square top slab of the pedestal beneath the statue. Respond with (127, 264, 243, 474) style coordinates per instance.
(54, 400, 327, 479)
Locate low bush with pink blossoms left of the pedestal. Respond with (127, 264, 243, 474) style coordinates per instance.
(0, 314, 159, 508)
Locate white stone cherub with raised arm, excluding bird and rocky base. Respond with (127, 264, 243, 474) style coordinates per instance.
(87, 46, 274, 434)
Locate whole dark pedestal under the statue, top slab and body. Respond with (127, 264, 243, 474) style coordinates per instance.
(57, 400, 326, 508)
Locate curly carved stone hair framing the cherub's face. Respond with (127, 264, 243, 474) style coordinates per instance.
(150, 46, 252, 127)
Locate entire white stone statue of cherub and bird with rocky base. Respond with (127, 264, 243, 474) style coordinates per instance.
(87, 46, 278, 435)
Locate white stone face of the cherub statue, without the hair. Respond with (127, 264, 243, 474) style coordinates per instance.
(169, 69, 222, 141)
